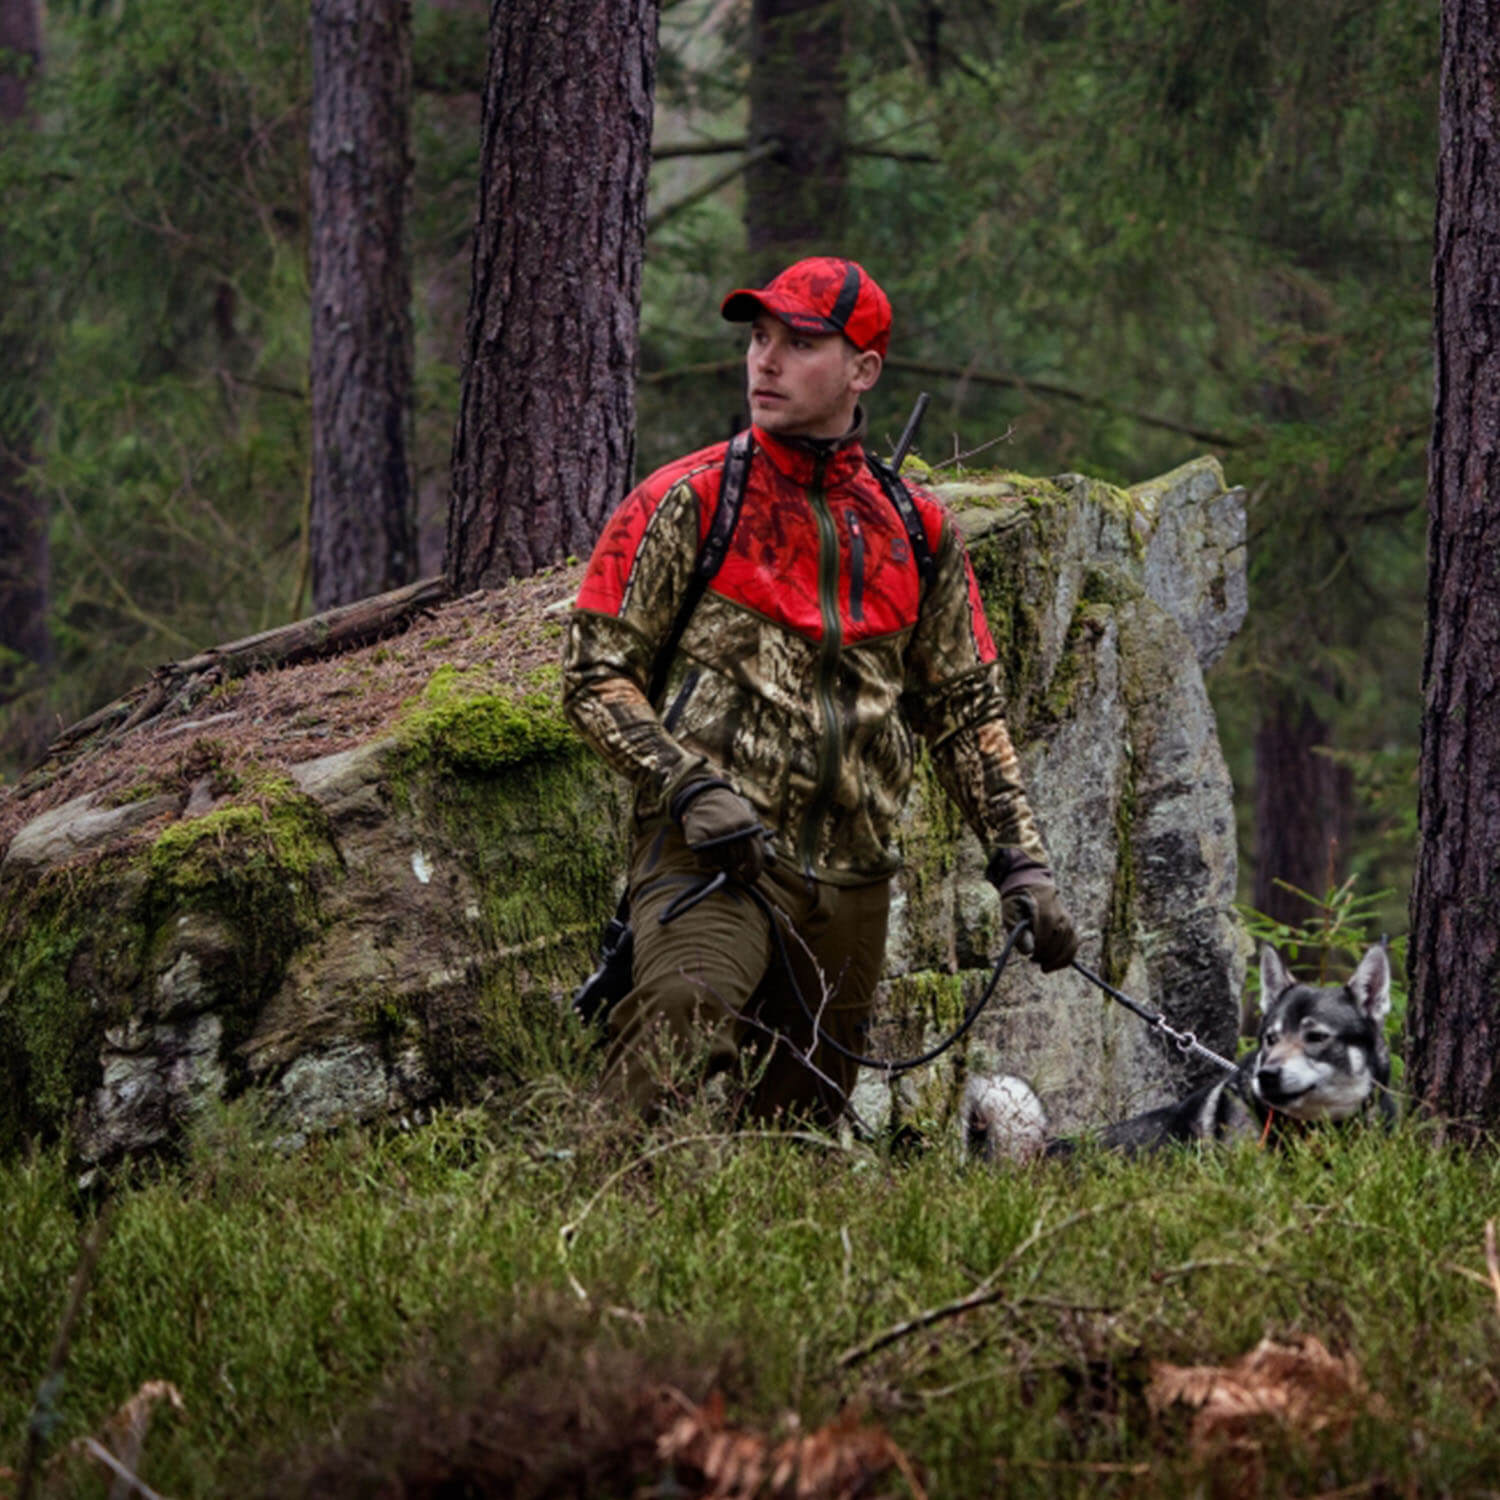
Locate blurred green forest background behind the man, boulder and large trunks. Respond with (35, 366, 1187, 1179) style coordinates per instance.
(0, 0, 1439, 932)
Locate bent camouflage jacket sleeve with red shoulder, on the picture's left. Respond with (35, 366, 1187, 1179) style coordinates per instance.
(563, 480, 705, 816)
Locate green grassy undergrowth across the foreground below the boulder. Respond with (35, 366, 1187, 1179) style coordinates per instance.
(0, 1083, 1500, 1500)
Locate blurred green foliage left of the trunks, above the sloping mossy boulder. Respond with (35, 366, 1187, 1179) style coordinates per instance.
(0, 0, 308, 744)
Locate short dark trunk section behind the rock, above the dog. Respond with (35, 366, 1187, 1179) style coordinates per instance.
(1251, 692, 1353, 927)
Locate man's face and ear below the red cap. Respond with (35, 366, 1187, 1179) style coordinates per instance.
(746, 312, 881, 438)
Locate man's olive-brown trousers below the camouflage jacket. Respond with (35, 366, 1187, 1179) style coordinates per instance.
(603, 824, 891, 1125)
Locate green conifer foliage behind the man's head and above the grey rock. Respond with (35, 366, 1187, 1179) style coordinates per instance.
(642, 0, 1439, 906)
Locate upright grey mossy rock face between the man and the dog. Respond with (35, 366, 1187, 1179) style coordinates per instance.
(860, 459, 1245, 1128)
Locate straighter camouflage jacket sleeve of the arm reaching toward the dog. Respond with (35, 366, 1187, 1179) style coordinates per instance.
(905, 515, 1049, 884)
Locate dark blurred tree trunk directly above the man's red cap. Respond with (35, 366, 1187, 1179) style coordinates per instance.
(746, 0, 849, 279)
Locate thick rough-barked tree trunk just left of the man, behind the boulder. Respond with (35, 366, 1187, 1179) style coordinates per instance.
(444, 0, 657, 593)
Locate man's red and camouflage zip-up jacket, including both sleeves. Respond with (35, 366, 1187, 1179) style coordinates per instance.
(564, 428, 1047, 885)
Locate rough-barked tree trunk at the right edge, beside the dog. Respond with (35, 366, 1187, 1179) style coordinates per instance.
(1407, 0, 1500, 1137)
